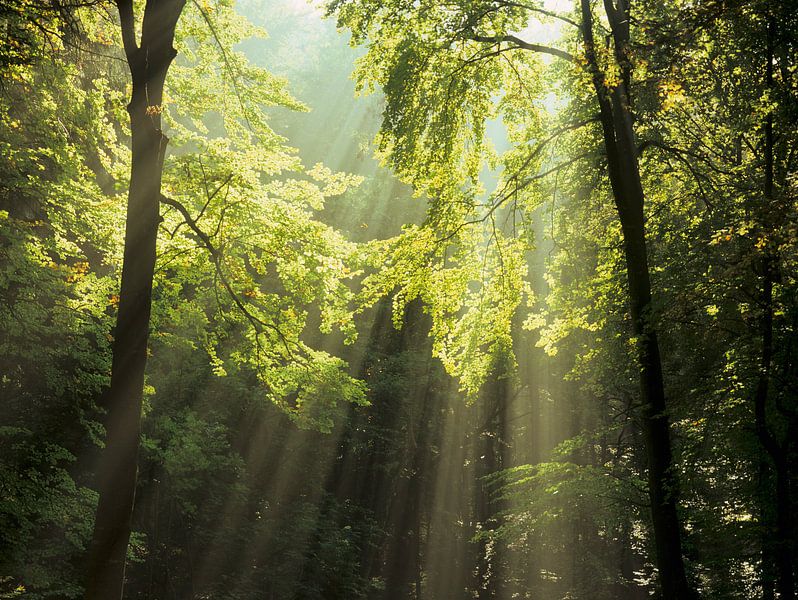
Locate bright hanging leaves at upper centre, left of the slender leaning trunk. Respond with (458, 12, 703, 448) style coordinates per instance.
(330, 2, 564, 395)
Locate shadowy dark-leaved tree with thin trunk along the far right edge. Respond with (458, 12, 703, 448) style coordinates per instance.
(654, 2, 795, 598)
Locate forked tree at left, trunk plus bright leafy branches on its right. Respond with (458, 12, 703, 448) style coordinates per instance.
(86, 0, 364, 598)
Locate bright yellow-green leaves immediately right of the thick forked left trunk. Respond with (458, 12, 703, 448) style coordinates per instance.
(148, 3, 372, 430)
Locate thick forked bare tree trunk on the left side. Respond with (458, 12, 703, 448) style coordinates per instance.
(85, 0, 185, 600)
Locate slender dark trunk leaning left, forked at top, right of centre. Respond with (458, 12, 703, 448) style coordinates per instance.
(581, 0, 695, 600)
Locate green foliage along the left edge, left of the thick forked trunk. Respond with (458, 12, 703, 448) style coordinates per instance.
(0, 14, 126, 598)
